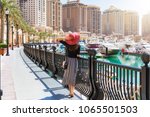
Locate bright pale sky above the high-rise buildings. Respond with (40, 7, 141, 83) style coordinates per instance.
(61, 0, 150, 15)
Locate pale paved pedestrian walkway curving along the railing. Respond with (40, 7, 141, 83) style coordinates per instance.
(1, 48, 85, 100)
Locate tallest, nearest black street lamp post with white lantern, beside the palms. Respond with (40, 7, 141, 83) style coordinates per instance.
(5, 9, 9, 56)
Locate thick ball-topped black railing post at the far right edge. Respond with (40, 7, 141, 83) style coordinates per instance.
(141, 53, 150, 100)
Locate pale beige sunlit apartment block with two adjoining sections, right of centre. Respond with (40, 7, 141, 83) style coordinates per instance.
(102, 6, 139, 36)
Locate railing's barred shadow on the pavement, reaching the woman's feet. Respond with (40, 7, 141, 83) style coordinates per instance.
(20, 51, 82, 100)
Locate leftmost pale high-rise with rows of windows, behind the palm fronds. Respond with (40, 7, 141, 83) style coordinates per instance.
(19, 0, 46, 26)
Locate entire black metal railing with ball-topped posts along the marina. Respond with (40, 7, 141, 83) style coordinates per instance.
(24, 44, 150, 100)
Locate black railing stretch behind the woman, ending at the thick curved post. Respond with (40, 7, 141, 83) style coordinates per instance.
(24, 44, 92, 99)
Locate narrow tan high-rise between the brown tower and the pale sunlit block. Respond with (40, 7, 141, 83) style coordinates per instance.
(87, 5, 101, 34)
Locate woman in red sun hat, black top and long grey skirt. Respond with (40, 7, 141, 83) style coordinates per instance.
(60, 33, 80, 97)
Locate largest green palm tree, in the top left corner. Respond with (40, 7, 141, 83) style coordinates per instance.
(0, 0, 35, 44)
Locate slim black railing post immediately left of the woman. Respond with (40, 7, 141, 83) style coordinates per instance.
(51, 46, 57, 78)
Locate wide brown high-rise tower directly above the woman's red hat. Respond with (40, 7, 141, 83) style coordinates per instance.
(62, 0, 87, 32)
